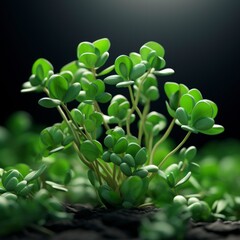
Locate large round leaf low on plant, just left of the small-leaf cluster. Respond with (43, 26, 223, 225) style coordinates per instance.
(80, 140, 100, 162)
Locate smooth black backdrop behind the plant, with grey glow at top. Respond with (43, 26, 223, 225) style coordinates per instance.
(0, 0, 240, 145)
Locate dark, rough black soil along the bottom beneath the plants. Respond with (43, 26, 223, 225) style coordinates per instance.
(0, 205, 240, 240)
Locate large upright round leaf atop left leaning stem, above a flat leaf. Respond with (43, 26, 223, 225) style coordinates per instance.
(48, 74, 69, 101)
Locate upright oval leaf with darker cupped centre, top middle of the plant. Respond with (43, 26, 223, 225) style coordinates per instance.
(114, 55, 133, 79)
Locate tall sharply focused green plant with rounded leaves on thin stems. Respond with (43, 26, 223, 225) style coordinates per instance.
(19, 38, 224, 208)
